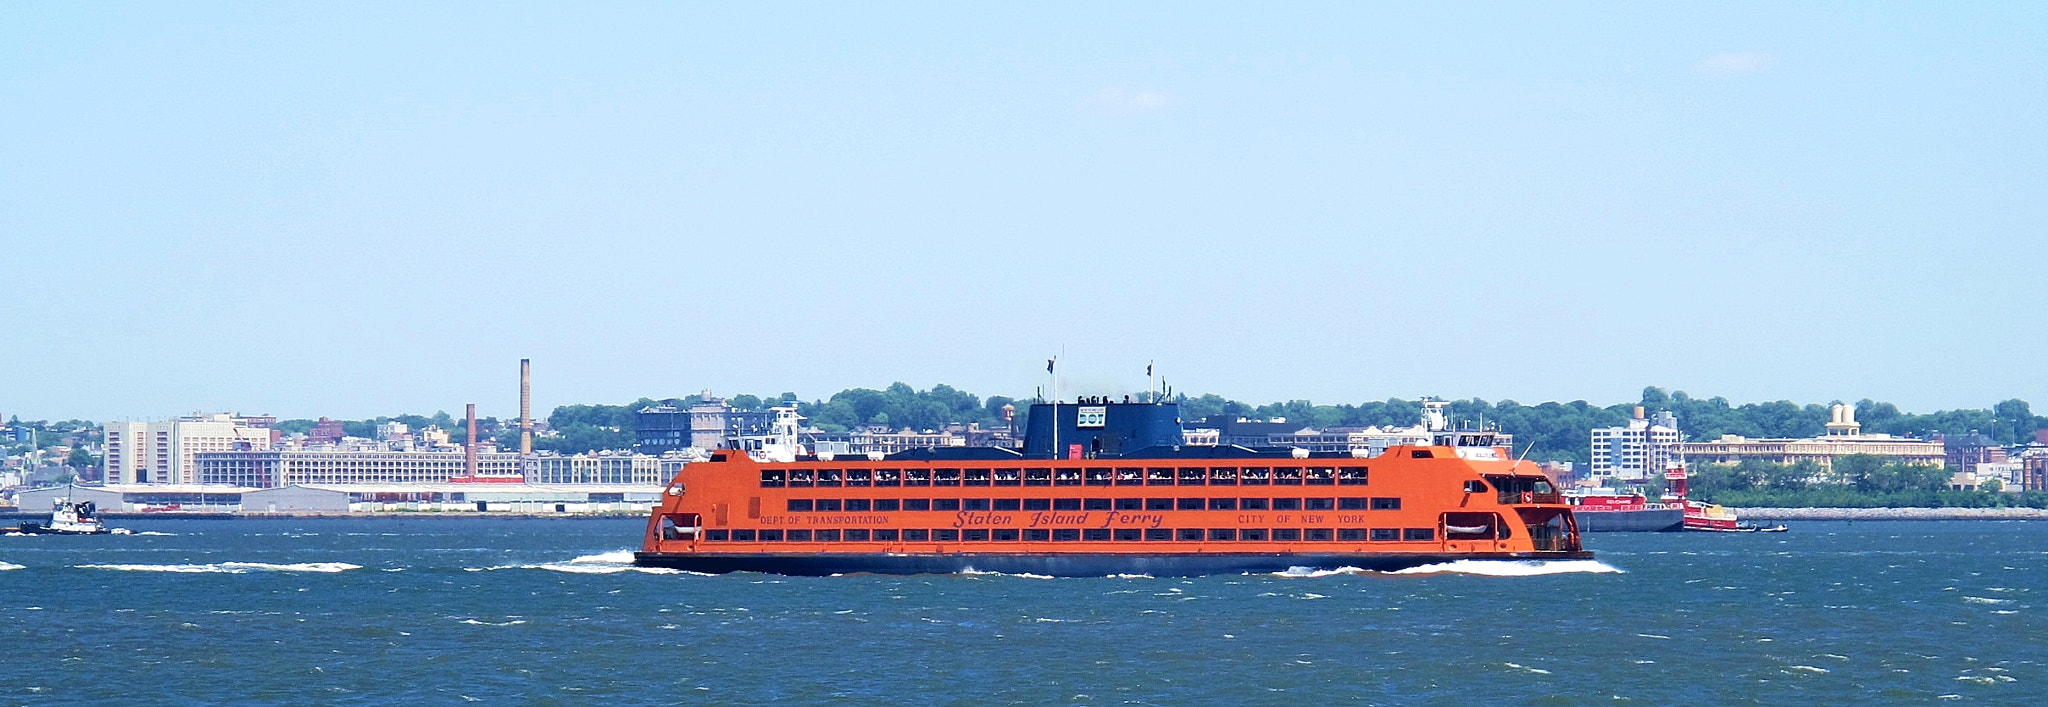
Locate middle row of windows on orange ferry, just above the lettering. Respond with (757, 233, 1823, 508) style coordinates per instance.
(786, 496, 1401, 512)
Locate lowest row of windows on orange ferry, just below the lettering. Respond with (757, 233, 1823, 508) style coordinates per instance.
(705, 529, 1436, 543)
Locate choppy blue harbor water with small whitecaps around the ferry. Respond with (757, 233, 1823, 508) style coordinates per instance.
(0, 518, 2048, 705)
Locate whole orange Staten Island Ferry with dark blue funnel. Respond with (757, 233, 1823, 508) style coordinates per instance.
(633, 400, 1593, 576)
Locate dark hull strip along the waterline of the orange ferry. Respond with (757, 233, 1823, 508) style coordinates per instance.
(633, 551, 1593, 578)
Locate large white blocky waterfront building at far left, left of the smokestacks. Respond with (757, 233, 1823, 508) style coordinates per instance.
(104, 414, 276, 484)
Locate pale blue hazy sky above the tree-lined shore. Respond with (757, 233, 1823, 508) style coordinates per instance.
(0, 2, 2048, 418)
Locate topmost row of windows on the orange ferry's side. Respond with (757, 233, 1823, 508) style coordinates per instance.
(762, 467, 1366, 488)
